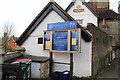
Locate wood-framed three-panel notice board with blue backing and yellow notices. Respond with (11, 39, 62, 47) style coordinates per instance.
(43, 28, 81, 53)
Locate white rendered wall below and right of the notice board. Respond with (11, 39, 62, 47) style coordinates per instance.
(54, 38, 92, 77)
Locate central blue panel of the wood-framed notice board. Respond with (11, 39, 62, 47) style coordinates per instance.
(52, 31, 68, 51)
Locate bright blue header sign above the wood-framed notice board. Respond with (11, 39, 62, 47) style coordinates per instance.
(47, 21, 77, 30)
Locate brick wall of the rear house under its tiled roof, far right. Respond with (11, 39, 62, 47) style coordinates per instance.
(99, 20, 120, 46)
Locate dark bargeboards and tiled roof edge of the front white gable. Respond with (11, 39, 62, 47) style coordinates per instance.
(17, 2, 91, 45)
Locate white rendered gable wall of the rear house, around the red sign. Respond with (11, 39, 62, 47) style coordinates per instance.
(68, 0, 98, 27)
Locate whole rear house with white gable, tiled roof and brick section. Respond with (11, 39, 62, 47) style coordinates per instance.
(66, 0, 120, 46)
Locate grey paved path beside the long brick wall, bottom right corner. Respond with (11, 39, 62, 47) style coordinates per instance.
(97, 50, 120, 80)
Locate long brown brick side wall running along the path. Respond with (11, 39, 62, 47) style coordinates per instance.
(88, 23, 112, 76)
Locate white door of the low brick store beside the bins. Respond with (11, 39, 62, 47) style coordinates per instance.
(31, 62, 40, 78)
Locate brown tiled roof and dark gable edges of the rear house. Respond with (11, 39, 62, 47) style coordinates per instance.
(66, 1, 118, 19)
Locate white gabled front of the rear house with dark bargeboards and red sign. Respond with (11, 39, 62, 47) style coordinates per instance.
(65, 0, 99, 27)
